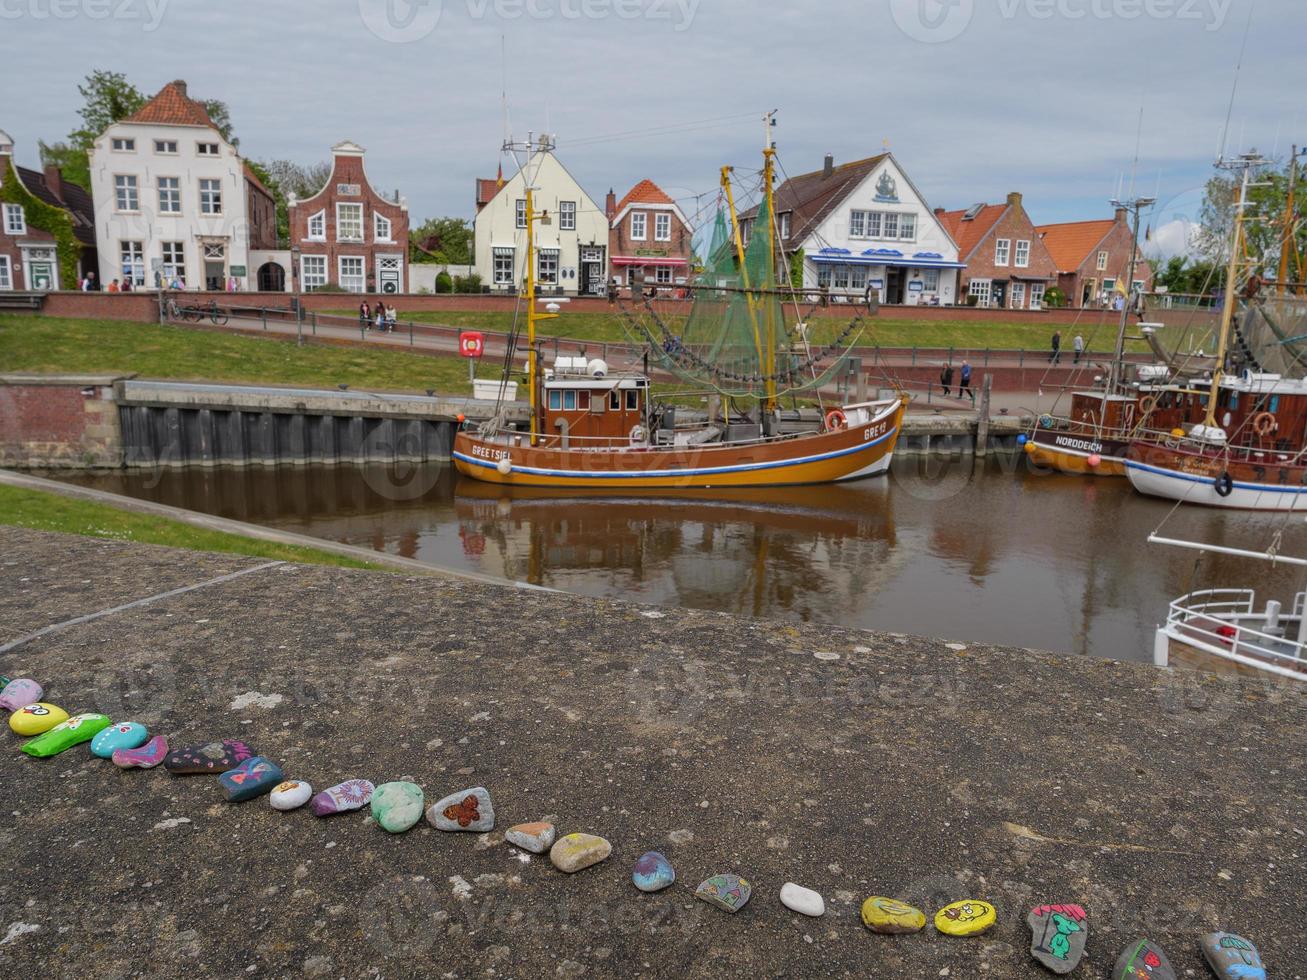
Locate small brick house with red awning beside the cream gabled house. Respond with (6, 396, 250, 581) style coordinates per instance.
(604, 180, 694, 286)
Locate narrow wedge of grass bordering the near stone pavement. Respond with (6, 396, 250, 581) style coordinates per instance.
(0, 485, 384, 570)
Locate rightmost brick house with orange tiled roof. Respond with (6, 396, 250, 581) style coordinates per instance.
(1038, 208, 1153, 308)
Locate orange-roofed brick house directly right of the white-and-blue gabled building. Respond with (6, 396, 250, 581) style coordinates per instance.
(936, 192, 1057, 310)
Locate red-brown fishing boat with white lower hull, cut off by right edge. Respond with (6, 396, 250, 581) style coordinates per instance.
(1125, 155, 1307, 511)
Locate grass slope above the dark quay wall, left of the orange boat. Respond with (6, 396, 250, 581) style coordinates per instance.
(0, 315, 471, 395)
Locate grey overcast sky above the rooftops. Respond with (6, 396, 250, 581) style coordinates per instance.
(0, 0, 1307, 257)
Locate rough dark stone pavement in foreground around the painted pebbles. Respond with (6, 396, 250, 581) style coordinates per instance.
(0, 528, 1307, 980)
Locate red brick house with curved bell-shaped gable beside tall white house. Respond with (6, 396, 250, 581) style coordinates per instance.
(289, 141, 409, 295)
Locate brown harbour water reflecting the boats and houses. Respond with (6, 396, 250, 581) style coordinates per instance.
(58, 457, 1307, 660)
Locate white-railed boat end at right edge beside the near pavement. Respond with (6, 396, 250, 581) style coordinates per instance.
(1166, 589, 1307, 670)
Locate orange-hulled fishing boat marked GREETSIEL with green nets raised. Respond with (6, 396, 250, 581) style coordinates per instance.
(454, 125, 907, 490)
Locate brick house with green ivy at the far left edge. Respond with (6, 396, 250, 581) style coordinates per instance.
(0, 131, 95, 293)
